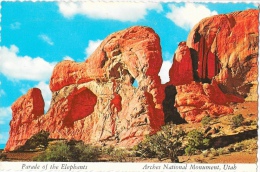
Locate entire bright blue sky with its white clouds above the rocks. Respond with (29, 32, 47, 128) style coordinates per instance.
(0, 2, 256, 148)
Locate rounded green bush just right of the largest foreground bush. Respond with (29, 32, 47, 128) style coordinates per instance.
(185, 129, 210, 155)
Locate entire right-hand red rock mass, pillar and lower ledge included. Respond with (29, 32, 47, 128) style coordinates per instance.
(168, 10, 258, 122)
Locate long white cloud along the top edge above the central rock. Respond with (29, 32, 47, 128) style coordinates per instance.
(58, 1, 162, 22)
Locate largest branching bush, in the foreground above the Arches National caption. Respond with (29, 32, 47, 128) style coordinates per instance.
(135, 124, 185, 162)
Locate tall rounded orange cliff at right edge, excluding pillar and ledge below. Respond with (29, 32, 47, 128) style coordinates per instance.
(187, 10, 259, 101)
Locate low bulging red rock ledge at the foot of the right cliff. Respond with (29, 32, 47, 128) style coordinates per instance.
(175, 81, 243, 122)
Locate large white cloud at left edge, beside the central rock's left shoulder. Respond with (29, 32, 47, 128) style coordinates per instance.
(0, 45, 56, 81)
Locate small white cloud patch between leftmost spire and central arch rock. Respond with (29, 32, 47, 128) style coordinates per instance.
(35, 82, 52, 111)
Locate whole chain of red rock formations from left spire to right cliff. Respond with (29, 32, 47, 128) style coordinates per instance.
(5, 10, 258, 151)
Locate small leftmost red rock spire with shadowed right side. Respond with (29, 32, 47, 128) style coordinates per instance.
(5, 88, 44, 150)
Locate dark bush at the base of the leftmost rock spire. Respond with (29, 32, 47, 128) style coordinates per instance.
(18, 131, 50, 151)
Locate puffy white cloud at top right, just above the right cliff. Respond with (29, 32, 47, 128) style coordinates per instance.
(166, 3, 218, 30)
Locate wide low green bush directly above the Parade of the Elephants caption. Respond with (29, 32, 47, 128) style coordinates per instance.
(34, 142, 100, 162)
